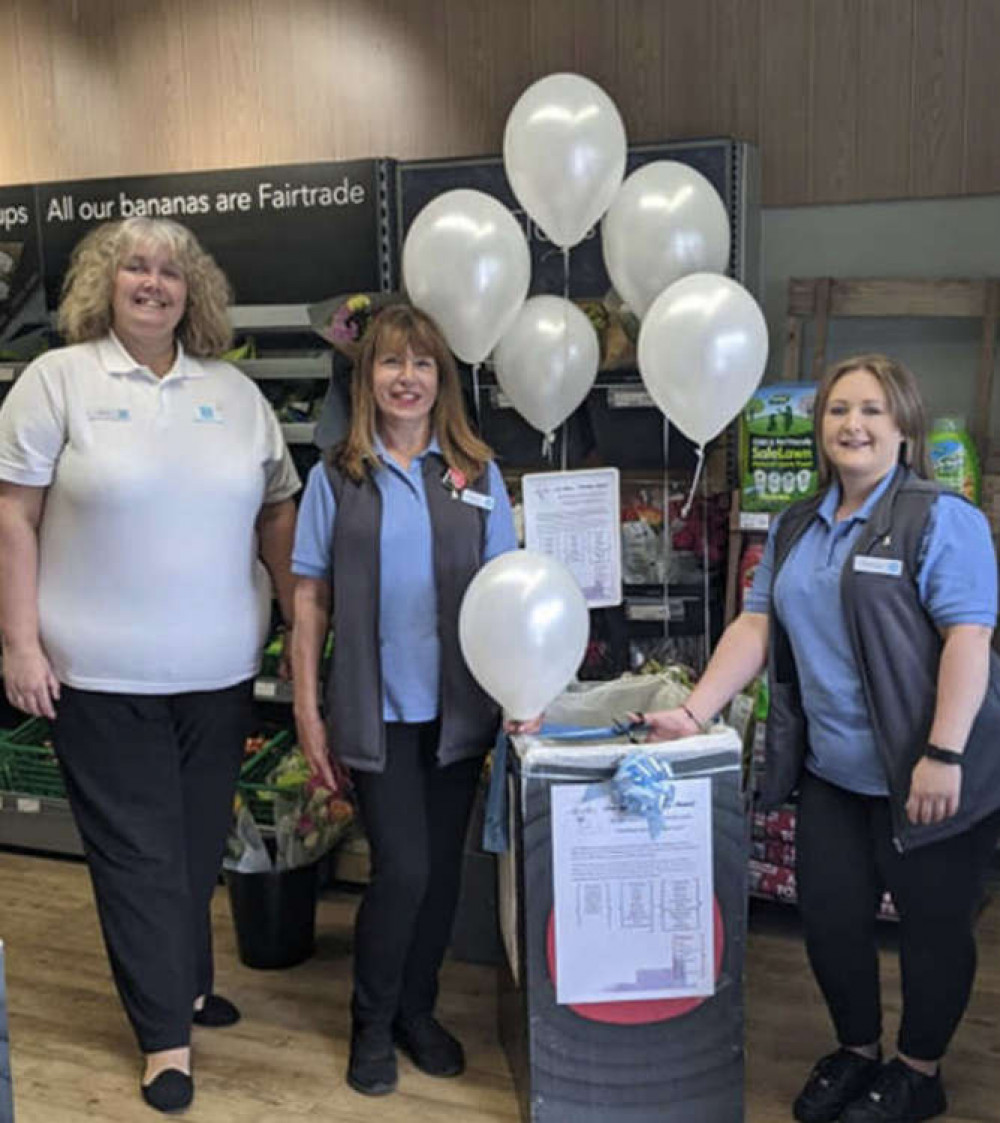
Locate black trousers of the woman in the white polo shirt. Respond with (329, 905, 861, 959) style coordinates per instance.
(54, 681, 253, 1052)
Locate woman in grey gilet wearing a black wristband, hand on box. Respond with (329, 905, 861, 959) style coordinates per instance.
(646, 355, 1000, 1123)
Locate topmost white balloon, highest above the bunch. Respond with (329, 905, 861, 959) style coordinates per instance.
(503, 74, 626, 249)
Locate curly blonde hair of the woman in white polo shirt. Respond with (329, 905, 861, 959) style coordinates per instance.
(58, 218, 233, 358)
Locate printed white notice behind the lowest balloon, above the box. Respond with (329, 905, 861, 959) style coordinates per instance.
(521, 468, 621, 609)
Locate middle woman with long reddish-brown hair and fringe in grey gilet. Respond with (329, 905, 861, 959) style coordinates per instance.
(292, 305, 516, 1095)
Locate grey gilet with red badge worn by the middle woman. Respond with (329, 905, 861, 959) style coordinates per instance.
(325, 453, 499, 772)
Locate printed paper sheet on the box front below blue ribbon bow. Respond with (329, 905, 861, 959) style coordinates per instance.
(552, 777, 715, 1004)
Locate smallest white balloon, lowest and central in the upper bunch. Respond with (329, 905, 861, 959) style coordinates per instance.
(493, 296, 601, 433)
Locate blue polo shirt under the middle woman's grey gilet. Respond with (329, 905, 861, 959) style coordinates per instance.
(292, 439, 517, 722)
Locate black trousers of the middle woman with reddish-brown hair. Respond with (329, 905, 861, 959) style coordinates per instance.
(352, 722, 483, 1025)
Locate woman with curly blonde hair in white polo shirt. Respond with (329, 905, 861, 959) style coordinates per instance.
(0, 219, 299, 1111)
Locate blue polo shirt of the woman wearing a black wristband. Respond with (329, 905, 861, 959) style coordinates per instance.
(744, 473, 997, 795)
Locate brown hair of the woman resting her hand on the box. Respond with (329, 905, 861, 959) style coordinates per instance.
(812, 354, 933, 485)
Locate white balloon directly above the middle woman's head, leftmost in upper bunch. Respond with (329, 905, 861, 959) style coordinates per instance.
(402, 189, 531, 363)
